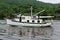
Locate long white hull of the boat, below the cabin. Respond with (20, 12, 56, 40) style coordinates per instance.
(7, 19, 51, 27)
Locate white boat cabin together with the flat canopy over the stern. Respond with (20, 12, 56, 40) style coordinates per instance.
(13, 14, 53, 23)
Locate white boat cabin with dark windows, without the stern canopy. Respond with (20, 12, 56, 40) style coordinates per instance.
(14, 15, 43, 23)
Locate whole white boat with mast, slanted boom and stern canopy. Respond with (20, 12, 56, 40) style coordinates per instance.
(6, 7, 54, 27)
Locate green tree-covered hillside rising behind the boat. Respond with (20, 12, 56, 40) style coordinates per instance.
(0, 0, 60, 19)
